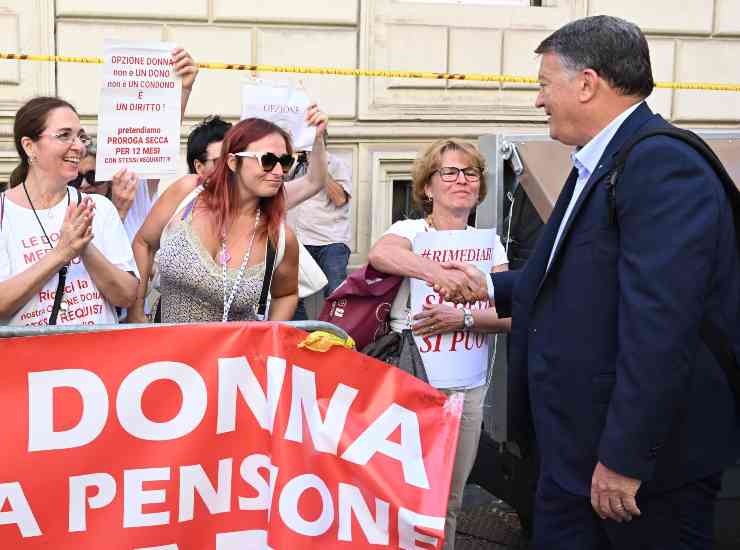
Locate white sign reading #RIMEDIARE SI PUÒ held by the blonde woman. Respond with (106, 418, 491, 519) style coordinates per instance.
(411, 229, 497, 388)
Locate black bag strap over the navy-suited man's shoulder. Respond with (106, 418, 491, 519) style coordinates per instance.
(607, 128, 740, 407)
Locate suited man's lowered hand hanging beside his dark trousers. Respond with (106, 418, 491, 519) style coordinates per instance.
(591, 462, 642, 523)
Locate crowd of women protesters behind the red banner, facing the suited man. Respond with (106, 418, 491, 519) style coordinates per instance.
(0, 37, 507, 548)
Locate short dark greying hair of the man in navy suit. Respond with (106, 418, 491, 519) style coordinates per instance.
(535, 15, 655, 98)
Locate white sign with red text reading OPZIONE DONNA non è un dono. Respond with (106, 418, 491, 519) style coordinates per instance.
(95, 40, 182, 181)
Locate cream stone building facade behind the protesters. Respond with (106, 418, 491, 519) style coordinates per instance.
(0, 0, 740, 265)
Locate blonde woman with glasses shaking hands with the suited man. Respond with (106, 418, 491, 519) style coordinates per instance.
(365, 139, 510, 550)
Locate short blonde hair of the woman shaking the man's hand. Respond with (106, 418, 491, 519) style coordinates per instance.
(411, 138, 488, 214)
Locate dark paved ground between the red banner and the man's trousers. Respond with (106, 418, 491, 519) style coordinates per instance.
(455, 485, 527, 550)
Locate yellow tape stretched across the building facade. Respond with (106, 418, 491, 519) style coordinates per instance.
(0, 52, 740, 92)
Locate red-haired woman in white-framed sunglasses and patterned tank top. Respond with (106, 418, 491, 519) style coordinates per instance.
(129, 106, 326, 322)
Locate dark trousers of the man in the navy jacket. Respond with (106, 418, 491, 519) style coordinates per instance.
(531, 473, 722, 550)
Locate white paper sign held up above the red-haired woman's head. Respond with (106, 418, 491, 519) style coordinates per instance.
(242, 78, 316, 151)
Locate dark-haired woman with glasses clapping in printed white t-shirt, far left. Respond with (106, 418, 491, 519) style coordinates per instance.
(0, 97, 138, 325)
